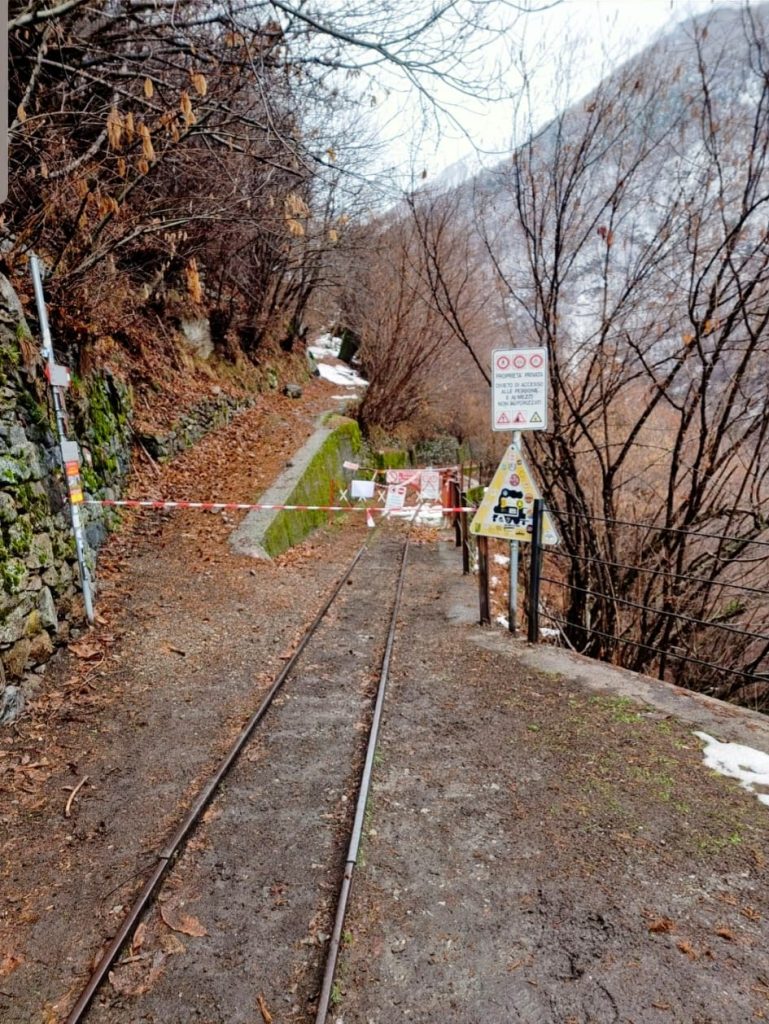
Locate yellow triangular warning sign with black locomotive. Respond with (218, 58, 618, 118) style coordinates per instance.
(470, 444, 559, 544)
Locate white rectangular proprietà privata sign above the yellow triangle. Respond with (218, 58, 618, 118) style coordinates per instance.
(492, 348, 548, 430)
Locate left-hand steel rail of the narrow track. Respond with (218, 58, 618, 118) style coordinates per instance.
(66, 540, 369, 1024)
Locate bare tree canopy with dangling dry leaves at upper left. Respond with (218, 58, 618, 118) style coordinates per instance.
(3, 0, 536, 368)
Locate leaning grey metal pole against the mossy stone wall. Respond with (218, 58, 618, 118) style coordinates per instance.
(30, 254, 93, 623)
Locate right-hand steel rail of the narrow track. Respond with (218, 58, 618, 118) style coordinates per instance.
(315, 536, 416, 1024)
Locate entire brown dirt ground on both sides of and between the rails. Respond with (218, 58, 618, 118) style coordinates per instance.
(0, 381, 769, 1024)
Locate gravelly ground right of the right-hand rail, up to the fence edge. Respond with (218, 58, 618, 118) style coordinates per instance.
(333, 546, 769, 1024)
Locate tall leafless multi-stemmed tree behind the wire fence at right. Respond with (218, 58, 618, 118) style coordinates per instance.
(478, 7, 769, 699)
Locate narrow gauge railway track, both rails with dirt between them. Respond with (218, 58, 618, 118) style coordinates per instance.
(66, 530, 409, 1024)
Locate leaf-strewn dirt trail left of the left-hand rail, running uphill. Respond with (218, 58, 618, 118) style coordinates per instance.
(0, 381, 366, 1024)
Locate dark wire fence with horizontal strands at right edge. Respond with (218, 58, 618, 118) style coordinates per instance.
(529, 506, 769, 711)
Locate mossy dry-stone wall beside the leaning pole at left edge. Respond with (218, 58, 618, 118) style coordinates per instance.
(0, 276, 130, 723)
